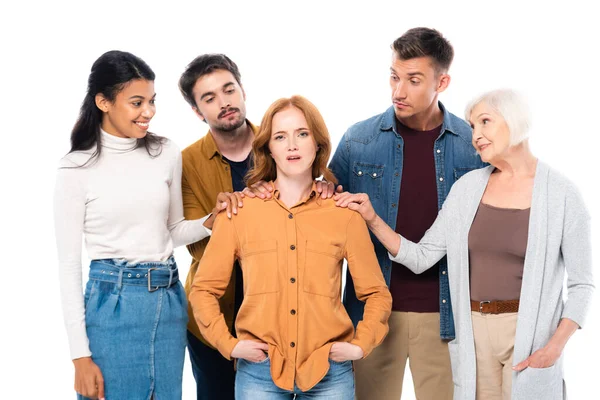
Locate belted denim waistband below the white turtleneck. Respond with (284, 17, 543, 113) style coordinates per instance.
(90, 256, 179, 292)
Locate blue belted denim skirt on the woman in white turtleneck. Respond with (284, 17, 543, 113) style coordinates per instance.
(78, 257, 188, 400)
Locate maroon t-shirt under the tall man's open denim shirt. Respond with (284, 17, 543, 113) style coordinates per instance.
(390, 121, 442, 312)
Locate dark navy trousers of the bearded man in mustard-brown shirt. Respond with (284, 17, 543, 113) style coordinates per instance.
(187, 331, 235, 400)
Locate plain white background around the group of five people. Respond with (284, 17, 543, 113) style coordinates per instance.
(0, 0, 600, 399)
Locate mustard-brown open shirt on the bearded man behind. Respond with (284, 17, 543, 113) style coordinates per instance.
(181, 120, 258, 344)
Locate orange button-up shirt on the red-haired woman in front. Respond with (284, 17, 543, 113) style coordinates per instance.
(190, 186, 392, 391)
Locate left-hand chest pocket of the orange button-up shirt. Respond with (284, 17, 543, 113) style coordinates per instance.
(241, 240, 279, 296)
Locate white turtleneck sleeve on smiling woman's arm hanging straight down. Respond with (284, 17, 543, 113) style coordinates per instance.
(54, 162, 92, 359)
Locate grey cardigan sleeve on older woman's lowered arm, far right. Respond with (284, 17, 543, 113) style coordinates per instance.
(560, 187, 594, 327)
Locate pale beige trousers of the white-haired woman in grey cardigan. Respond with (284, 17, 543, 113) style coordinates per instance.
(471, 311, 517, 400)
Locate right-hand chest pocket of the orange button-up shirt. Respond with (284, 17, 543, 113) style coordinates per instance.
(303, 240, 342, 298)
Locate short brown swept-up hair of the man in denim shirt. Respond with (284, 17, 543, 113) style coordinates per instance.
(392, 28, 454, 73)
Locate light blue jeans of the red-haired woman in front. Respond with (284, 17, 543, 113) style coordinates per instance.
(235, 358, 354, 400)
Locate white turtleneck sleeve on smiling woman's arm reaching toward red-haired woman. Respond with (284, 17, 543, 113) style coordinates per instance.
(167, 150, 211, 247)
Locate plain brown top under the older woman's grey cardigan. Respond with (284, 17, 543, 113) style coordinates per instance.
(469, 203, 530, 301)
